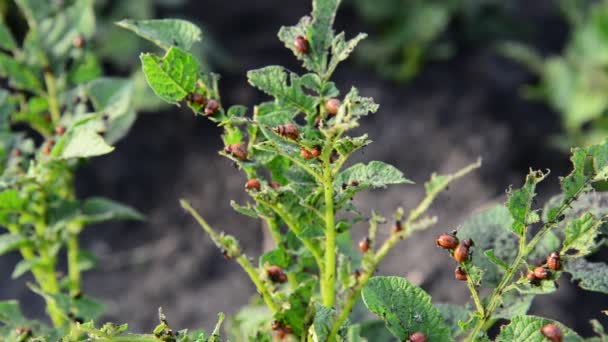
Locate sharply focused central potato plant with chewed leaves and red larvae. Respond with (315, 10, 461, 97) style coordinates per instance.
(127, 0, 480, 341)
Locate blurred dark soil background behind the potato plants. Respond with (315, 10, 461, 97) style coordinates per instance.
(0, 0, 608, 335)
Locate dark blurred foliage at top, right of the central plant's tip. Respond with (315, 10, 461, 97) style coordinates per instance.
(353, 0, 513, 81)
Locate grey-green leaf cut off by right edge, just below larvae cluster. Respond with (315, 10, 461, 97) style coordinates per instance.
(564, 258, 608, 293)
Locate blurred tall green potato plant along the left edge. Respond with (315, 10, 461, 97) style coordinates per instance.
(0, 0, 143, 341)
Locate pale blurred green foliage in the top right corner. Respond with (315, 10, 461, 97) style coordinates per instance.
(502, 1, 608, 150)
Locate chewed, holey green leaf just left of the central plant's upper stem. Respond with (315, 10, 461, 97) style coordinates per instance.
(247, 66, 318, 116)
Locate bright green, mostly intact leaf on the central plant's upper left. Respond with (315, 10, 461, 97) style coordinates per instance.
(140, 47, 200, 104)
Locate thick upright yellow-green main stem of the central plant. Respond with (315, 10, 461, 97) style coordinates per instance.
(321, 147, 336, 308)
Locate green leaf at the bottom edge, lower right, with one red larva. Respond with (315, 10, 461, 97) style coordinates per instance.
(496, 316, 583, 342)
